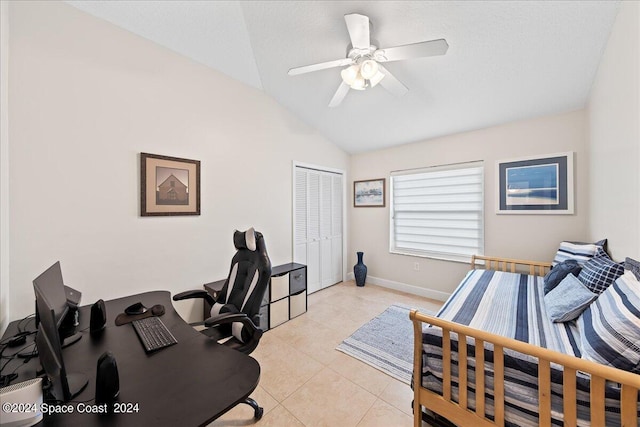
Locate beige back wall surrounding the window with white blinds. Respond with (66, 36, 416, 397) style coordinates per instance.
(348, 110, 589, 299)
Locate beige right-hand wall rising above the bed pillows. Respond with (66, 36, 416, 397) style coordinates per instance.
(587, 1, 640, 261)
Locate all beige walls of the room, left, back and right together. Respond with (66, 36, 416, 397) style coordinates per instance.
(7, 2, 640, 324)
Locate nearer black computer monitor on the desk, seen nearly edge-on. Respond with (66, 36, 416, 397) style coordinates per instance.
(35, 287, 89, 402)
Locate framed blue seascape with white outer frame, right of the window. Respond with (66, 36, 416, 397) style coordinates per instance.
(496, 152, 573, 214)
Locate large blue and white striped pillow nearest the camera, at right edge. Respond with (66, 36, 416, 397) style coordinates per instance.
(578, 271, 640, 373)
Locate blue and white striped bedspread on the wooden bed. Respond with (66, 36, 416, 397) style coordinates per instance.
(422, 270, 640, 426)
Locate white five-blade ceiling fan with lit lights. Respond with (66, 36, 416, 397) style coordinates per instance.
(288, 13, 449, 107)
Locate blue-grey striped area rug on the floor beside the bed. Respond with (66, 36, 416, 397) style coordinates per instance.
(336, 304, 431, 384)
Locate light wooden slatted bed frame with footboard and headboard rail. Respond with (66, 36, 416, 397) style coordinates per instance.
(409, 256, 640, 427)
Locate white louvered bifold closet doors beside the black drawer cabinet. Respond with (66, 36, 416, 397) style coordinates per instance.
(294, 165, 343, 293)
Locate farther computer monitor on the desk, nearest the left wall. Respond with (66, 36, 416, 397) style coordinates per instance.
(33, 261, 82, 347)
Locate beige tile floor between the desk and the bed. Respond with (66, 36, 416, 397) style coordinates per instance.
(210, 281, 442, 427)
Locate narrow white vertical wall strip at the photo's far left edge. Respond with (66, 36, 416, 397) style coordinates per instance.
(0, 2, 11, 335)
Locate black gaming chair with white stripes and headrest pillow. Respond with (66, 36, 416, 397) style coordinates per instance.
(173, 228, 271, 354)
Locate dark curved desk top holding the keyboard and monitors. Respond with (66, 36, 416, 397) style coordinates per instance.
(4, 291, 260, 426)
